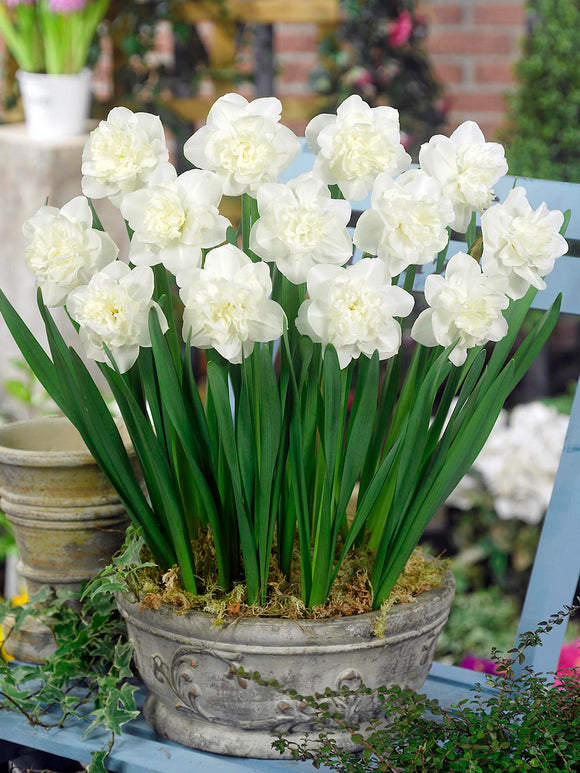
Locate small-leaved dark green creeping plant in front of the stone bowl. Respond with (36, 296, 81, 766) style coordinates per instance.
(255, 606, 580, 773)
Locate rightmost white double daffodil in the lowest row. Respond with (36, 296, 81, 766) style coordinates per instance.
(411, 252, 509, 365)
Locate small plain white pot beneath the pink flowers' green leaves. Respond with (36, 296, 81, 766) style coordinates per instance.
(16, 69, 92, 140)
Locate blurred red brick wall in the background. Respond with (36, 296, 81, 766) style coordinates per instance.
(275, 0, 525, 138)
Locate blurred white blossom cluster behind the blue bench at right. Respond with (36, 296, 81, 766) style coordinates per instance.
(449, 402, 570, 524)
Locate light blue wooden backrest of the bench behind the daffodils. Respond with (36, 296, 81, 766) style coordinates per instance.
(280, 141, 580, 673)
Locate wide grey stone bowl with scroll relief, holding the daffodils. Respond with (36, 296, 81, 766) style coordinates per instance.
(117, 573, 455, 759)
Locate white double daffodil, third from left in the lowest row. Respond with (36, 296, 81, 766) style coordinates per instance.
(296, 258, 414, 368)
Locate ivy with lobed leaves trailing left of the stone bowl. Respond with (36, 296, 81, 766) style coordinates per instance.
(0, 536, 146, 773)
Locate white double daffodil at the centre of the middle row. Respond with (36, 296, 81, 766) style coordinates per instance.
(250, 174, 352, 284)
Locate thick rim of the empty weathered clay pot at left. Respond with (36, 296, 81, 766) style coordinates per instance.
(0, 416, 134, 467)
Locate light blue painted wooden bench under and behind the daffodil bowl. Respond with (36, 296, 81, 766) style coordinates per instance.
(0, 146, 580, 773)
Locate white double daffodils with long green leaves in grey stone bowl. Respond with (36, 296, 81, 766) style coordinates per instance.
(0, 94, 566, 756)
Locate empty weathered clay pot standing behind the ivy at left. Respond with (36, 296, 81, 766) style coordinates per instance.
(0, 417, 128, 661)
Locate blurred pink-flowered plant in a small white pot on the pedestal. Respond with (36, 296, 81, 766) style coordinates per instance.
(0, 0, 109, 140)
